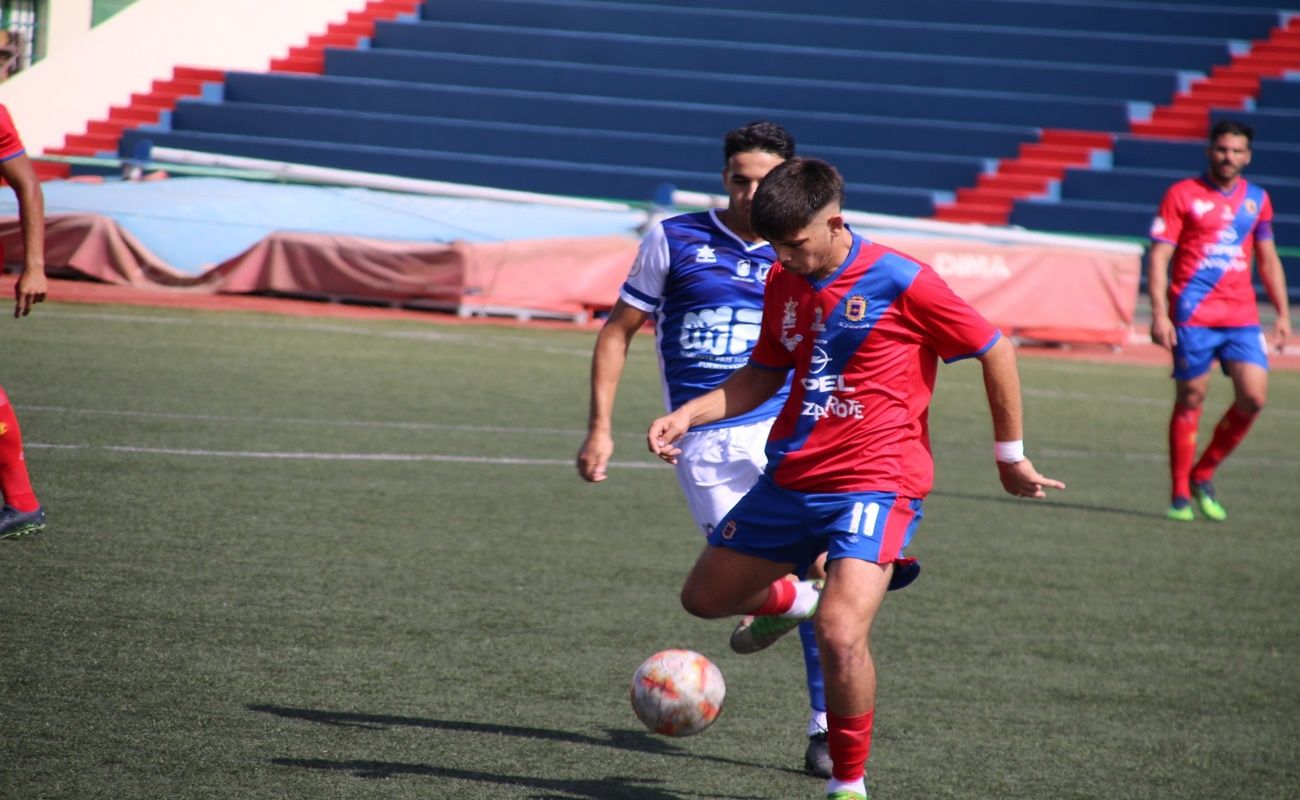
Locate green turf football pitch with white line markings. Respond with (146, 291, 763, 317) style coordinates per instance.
(0, 304, 1300, 800)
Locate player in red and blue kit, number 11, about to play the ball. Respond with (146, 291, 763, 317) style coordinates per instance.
(646, 159, 1065, 800)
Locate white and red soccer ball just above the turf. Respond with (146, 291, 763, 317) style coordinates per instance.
(632, 650, 727, 736)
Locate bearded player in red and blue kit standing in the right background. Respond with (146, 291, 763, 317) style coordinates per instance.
(1147, 120, 1291, 522)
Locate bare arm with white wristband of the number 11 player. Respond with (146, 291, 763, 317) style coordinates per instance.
(979, 337, 1065, 498)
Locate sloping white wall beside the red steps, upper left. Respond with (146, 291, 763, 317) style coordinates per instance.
(0, 0, 367, 153)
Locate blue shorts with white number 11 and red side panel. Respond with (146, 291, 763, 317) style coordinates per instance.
(709, 475, 923, 575)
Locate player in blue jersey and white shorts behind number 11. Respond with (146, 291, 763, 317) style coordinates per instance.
(577, 122, 831, 778)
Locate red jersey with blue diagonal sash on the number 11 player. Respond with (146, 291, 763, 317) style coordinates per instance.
(750, 235, 1001, 498)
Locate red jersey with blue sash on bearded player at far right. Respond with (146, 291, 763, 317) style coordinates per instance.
(1151, 177, 1273, 328)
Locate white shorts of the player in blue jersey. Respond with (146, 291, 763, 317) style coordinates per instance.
(677, 418, 776, 535)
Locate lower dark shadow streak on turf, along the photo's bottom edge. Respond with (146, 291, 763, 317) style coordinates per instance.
(272, 758, 742, 800)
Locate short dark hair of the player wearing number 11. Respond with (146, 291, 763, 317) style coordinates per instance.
(749, 159, 844, 242)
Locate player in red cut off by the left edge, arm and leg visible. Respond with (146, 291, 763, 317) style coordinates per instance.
(0, 105, 47, 539)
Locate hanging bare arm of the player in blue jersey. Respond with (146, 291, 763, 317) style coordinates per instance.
(577, 299, 650, 483)
